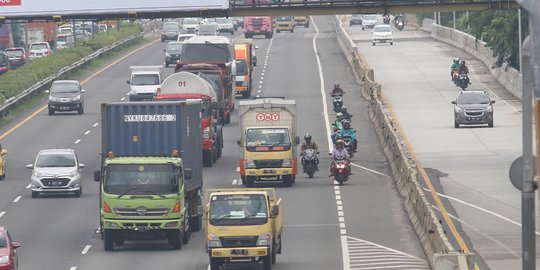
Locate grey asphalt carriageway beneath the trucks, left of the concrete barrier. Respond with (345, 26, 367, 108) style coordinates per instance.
(0, 17, 429, 270)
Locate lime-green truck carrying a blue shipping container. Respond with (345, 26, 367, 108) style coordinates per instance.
(94, 101, 203, 251)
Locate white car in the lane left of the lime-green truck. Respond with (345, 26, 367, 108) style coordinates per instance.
(26, 149, 84, 198)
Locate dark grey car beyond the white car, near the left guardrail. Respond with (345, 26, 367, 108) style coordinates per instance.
(45, 80, 84, 115)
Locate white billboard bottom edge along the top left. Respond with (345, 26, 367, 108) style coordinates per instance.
(0, 0, 229, 17)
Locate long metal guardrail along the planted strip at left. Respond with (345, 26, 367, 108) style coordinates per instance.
(0, 32, 144, 117)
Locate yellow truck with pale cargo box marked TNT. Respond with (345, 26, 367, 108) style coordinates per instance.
(237, 98, 300, 187)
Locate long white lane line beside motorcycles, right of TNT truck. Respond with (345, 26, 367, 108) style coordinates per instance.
(310, 17, 351, 270)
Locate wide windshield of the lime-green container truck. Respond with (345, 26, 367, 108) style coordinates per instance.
(103, 164, 179, 195)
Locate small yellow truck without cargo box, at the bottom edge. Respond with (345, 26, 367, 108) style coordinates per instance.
(204, 188, 283, 270)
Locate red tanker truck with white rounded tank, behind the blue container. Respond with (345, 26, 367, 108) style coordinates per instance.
(154, 72, 223, 167)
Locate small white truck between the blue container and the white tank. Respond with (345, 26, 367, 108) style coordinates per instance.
(126, 66, 163, 101)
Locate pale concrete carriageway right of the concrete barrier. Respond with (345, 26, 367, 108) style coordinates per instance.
(348, 18, 539, 269)
